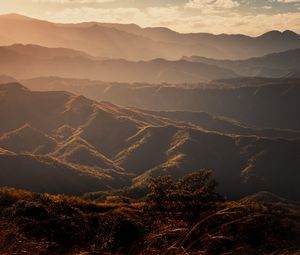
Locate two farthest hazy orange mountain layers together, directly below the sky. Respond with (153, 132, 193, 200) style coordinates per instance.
(0, 14, 300, 83)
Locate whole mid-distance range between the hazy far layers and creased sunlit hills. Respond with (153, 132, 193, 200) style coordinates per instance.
(22, 77, 300, 129)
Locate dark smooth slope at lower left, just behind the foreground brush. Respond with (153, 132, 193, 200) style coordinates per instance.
(0, 149, 109, 195)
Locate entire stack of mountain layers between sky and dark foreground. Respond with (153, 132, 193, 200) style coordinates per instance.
(0, 14, 300, 203)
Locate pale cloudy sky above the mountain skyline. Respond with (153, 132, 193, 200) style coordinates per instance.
(0, 0, 300, 36)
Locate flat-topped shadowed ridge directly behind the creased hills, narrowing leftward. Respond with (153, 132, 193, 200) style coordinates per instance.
(95, 81, 300, 130)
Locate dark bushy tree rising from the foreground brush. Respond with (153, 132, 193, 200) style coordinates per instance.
(147, 170, 224, 219)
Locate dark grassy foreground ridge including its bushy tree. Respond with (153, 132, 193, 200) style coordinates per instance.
(0, 172, 300, 254)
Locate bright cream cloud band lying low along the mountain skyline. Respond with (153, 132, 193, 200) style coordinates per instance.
(48, 3, 300, 35)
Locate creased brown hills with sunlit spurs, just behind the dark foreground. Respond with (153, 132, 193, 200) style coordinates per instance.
(0, 83, 300, 200)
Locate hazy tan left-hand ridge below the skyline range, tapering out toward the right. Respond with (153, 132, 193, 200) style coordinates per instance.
(0, 45, 237, 83)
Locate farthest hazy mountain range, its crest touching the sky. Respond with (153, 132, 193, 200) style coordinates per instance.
(0, 14, 300, 61)
